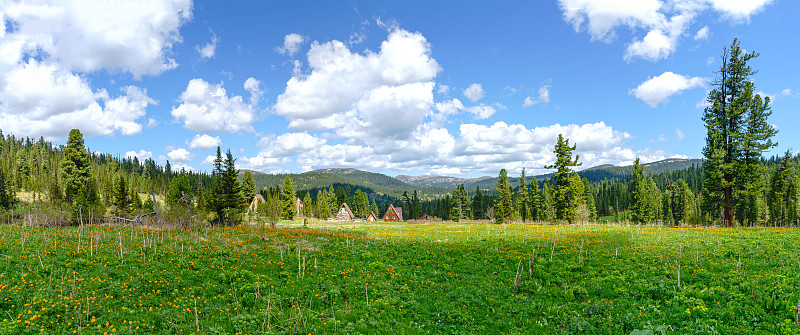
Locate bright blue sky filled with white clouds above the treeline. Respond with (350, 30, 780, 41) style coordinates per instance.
(0, 0, 800, 176)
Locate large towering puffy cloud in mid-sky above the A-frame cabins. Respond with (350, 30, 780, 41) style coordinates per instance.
(273, 29, 441, 140)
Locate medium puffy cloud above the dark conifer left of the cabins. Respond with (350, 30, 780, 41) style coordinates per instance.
(171, 79, 255, 133)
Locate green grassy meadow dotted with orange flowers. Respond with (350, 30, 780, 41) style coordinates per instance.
(0, 222, 800, 334)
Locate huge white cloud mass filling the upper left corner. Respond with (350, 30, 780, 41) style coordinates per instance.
(0, 1, 191, 140)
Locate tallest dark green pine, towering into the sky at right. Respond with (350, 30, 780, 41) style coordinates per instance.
(703, 39, 777, 227)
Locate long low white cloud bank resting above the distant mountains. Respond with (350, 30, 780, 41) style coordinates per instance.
(288, 122, 644, 174)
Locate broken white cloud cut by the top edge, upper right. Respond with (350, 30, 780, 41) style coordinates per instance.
(559, 0, 772, 61)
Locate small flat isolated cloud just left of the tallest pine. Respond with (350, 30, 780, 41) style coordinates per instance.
(628, 71, 708, 107)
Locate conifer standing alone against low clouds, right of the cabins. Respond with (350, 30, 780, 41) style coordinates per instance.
(544, 134, 584, 223)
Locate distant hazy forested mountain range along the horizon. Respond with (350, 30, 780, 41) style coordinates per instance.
(247, 158, 702, 198)
